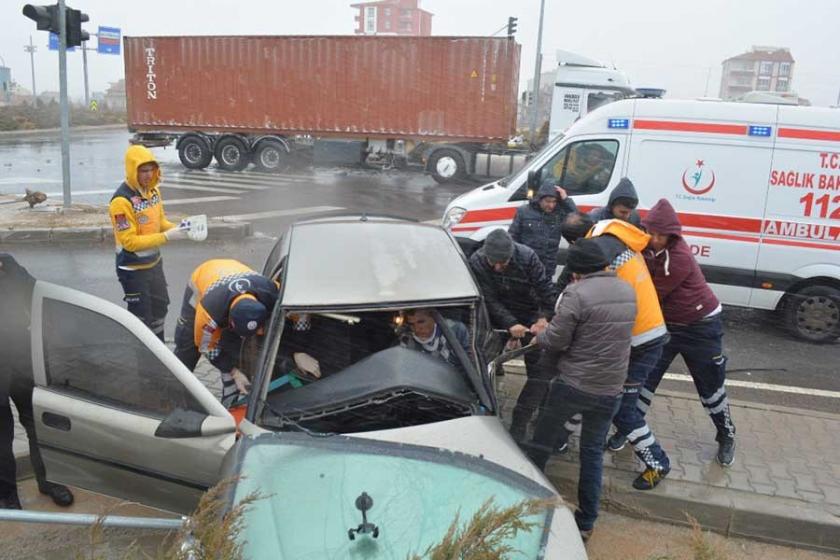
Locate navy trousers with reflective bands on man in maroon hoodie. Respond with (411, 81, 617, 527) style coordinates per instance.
(638, 314, 735, 441)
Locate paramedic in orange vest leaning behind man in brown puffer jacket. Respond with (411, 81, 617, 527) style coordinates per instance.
(559, 213, 671, 490)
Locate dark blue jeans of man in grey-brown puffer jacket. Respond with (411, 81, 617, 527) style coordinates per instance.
(525, 379, 620, 531)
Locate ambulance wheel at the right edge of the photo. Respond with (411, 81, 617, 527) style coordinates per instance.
(785, 284, 840, 342)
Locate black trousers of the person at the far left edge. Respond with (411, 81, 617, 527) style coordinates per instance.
(0, 376, 47, 496)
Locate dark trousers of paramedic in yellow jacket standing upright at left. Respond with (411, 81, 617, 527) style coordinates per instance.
(117, 259, 169, 340)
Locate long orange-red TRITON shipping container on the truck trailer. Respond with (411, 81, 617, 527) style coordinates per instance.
(125, 36, 520, 142)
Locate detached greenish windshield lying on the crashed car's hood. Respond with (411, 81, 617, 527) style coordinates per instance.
(235, 434, 553, 559)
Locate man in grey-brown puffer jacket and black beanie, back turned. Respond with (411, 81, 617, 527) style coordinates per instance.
(524, 239, 636, 541)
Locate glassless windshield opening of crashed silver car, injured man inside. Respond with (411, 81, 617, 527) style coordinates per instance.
(261, 306, 483, 433)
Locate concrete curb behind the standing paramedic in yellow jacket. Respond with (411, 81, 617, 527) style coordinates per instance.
(0, 222, 253, 244)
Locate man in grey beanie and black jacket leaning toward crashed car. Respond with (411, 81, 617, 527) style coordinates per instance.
(470, 229, 557, 441)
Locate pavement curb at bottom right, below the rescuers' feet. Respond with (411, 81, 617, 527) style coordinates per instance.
(546, 460, 840, 554)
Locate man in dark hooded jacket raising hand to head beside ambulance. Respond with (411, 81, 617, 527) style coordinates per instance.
(508, 179, 577, 278)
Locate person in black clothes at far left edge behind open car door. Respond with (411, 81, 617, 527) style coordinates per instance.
(0, 253, 73, 509)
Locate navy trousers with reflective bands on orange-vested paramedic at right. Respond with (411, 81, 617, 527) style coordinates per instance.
(613, 337, 671, 471)
